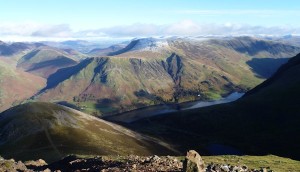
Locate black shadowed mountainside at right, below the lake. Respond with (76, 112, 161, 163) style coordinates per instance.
(129, 55, 300, 160)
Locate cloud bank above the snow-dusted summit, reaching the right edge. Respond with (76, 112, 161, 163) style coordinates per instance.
(77, 20, 300, 37)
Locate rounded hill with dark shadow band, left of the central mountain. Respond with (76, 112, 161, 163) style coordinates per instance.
(17, 46, 80, 78)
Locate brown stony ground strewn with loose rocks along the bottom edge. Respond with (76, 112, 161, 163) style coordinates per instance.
(0, 155, 272, 172)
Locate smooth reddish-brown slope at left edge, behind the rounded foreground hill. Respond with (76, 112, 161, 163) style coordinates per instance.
(0, 59, 46, 112)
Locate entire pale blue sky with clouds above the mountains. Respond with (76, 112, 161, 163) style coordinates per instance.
(0, 0, 300, 41)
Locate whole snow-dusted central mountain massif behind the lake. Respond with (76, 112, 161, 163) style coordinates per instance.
(35, 37, 300, 115)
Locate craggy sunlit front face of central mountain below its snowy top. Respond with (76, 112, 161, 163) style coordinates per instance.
(36, 58, 173, 115)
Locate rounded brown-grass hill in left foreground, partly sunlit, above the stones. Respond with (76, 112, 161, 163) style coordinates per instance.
(0, 102, 172, 161)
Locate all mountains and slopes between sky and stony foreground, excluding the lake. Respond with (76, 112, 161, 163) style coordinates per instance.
(0, 37, 300, 161)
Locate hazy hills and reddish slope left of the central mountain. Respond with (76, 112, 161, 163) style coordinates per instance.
(0, 41, 85, 112)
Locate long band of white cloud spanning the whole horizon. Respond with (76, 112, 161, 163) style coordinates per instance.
(0, 20, 300, 41)
